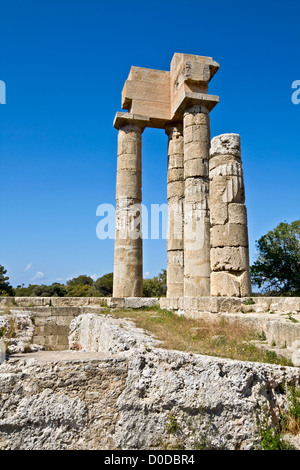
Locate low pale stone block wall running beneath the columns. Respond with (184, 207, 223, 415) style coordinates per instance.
(0, 297, 300, 350)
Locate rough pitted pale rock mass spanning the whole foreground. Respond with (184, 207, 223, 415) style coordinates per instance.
(0, 314, 300, 449)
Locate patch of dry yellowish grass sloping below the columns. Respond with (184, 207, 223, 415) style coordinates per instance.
(111, 308, 292, 365)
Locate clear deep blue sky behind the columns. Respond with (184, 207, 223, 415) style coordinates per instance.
(0, 0, 300, 286)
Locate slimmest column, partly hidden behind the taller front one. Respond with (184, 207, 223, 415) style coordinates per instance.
(166, 123, 184, 297)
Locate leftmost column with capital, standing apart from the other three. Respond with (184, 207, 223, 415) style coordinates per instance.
(113, 113, 144, 297)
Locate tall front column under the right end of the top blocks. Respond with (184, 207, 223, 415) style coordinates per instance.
(183, 104, 210, 297)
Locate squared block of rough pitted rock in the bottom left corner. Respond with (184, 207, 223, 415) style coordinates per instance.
(0, 353, 127, 450)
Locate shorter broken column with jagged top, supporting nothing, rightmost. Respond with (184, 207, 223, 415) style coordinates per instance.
(209, 134, 251, 297)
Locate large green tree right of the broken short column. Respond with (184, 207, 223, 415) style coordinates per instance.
(250, 220, 300, 296)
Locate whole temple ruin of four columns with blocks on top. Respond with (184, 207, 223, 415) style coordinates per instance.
(113, 53, 251, 298)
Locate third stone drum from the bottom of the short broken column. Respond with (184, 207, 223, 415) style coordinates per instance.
(210, 223, 248, 248)
